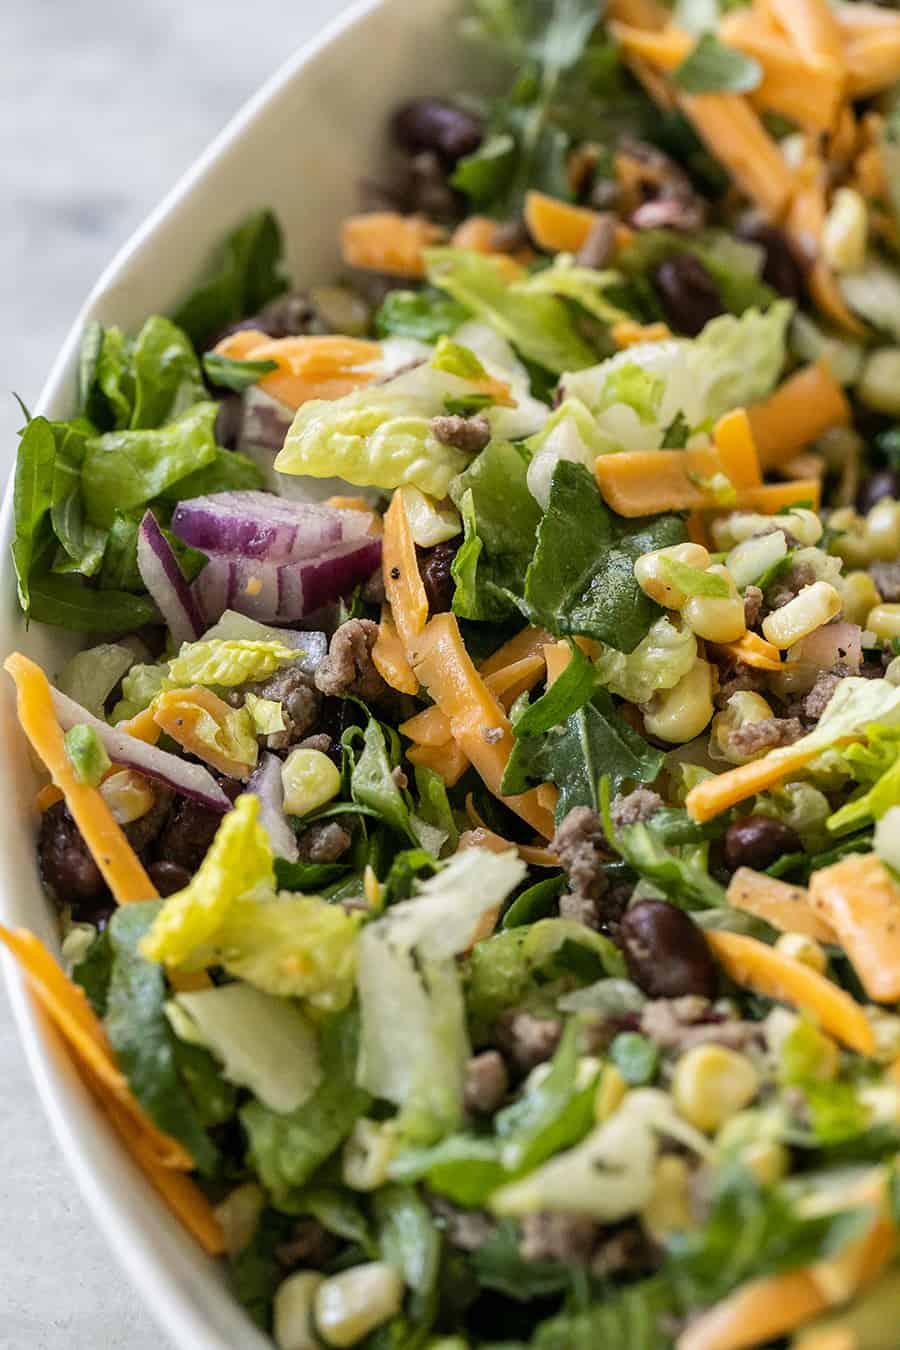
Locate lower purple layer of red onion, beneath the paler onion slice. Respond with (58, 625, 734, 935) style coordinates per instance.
(194, 535, 382, 624)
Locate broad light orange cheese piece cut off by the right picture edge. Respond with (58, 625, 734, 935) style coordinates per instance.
(810, 853, 900, 1003)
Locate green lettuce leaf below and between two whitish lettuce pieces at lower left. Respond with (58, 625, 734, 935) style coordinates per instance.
(240, 1011, 371, 1204)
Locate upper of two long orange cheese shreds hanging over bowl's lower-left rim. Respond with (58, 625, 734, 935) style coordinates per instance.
(0, 925, 193, 1172)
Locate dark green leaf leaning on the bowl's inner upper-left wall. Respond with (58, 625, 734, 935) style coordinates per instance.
(174, 211, 287, 350)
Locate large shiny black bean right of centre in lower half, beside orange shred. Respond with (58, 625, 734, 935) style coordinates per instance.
(619, 900, 716, 999)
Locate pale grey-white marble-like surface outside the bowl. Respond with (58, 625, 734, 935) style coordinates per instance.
(0, 0, 348, 1350)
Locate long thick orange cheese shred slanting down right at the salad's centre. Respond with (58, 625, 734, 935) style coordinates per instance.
(410, 614, 555, 838)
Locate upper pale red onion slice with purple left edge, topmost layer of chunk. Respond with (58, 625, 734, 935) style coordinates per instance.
(171, 491, 371, 563)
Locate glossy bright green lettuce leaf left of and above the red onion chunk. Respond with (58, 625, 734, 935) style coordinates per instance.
(81, 402, 219, 528)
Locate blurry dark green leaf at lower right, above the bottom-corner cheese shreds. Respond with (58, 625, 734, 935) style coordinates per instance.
(667, 1166, 872, 1307)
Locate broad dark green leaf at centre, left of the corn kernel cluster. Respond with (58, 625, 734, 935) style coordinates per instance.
(525, 460, 685, 652)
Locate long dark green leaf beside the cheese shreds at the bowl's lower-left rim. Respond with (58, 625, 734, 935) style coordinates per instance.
(104, 900, 219, 1175)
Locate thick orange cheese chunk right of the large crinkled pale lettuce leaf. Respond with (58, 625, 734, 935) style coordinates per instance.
(748, 362, 851, 468)
